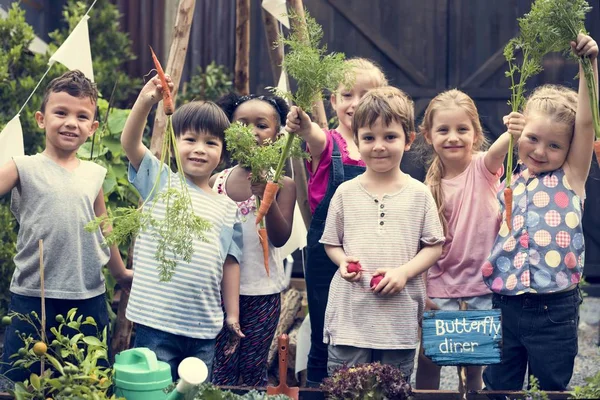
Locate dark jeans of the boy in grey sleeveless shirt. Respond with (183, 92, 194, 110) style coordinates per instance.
(0, 293, 110, 382)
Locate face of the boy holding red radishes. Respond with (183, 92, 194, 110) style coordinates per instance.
(357, 118, 410, 174)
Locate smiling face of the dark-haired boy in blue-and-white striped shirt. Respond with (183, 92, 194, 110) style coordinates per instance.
(177, 131, 223, 186)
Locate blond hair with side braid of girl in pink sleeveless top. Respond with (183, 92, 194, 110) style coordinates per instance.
(419, 89, 487, 233)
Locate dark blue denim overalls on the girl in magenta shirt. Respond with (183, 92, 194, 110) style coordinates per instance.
(304, 139, 365, 386)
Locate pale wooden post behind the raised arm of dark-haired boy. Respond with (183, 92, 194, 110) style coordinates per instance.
(150, 0, 196, 157)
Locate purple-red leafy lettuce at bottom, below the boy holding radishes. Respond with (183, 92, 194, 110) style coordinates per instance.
(321, 362, 413, 400)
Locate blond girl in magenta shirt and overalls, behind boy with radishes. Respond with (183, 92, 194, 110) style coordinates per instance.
(286, 58, 423, 386)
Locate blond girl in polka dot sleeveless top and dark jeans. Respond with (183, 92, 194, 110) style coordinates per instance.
(482, 34, 598, 390)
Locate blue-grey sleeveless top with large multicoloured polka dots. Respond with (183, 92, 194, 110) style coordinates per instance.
(482, 164, 584, 295)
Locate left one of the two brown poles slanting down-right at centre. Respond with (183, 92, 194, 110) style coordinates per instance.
(262, 9, 312, 229)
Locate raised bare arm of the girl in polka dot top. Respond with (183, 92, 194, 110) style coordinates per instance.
(566, 33, 598, 192)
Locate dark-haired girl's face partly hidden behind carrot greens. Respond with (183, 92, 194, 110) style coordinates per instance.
(233, 99, 279, 145)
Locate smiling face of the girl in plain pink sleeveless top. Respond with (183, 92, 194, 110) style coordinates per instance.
(425, 107, 476, 165)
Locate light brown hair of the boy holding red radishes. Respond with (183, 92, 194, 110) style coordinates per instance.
(352, 86, 415, 143)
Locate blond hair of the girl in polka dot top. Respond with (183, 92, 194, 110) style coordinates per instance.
(523, 85, 577, 129)
